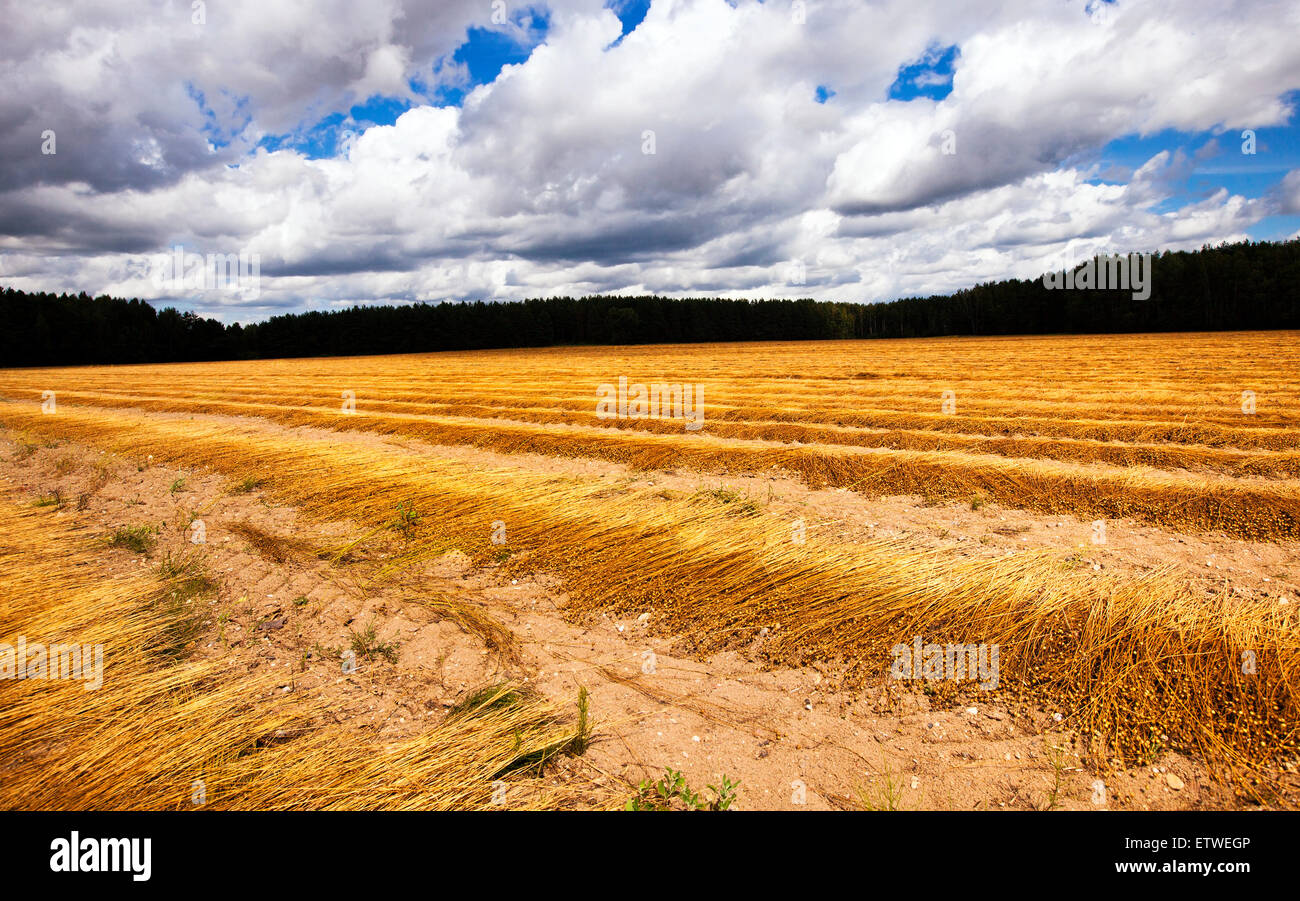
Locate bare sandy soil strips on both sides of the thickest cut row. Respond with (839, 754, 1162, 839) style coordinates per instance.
(0, 418, 1300, 810)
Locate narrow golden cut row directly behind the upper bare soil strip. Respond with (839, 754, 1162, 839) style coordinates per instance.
(12, 392, 1300, 540)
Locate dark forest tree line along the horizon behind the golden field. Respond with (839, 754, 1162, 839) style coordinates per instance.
(0, 241, 1300, 367)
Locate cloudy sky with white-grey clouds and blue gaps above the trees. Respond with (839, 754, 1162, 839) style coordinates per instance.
(0, 0, 1300, 322)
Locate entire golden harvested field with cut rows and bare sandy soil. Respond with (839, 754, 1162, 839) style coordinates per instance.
(0, 333, 1300, 809)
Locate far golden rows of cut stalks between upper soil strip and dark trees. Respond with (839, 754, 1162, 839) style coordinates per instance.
(0, 333, 1300, 540)
